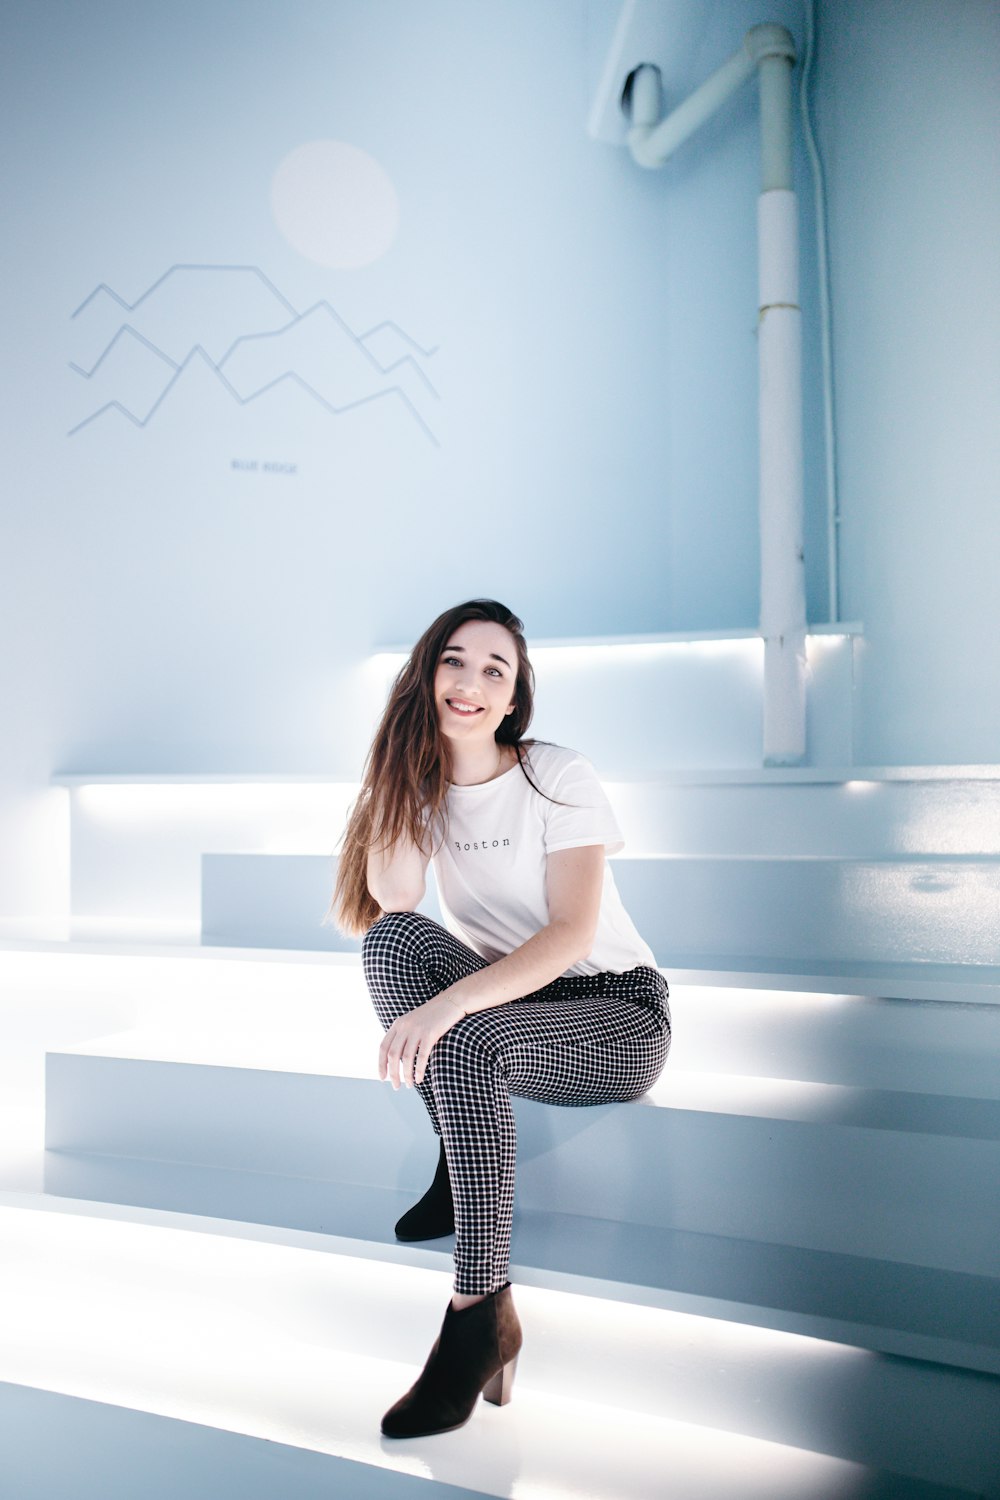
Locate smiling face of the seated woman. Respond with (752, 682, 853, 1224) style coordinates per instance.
(433, 620, 517, 743)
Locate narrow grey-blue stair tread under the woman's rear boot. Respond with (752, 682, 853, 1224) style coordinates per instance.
(31, 1152, 1000, 1373)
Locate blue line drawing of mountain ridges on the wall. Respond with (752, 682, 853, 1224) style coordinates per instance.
(67, 264, 439, 447)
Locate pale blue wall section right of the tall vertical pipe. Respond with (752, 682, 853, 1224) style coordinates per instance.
(817, 0, 1000, 765)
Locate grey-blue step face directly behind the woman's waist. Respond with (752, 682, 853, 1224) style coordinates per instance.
(194, 854, 1000, 980)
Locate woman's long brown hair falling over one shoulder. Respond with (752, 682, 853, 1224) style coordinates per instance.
(328, 599, 535, 936)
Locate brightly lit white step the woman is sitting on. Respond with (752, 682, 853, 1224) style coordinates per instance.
(11, 944, 1000, 1100)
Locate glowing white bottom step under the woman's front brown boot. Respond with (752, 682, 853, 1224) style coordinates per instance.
(0, 1203, 1000, 1500)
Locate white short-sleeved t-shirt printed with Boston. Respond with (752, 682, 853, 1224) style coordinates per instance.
(432, 744, 657, 974)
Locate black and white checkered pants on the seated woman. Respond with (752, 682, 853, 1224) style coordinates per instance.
(361, 912, 670, 1295)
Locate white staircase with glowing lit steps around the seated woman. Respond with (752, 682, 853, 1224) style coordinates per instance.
(0, 741, 1000, 1500)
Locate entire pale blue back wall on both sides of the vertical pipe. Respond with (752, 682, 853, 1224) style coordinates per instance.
(0, 0, 1000, 914)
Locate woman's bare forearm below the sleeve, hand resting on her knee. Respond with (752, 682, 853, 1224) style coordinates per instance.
(380, 845, 604, 1089)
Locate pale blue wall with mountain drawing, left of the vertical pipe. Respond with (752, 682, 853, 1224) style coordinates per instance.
(0, 0, 815, 911)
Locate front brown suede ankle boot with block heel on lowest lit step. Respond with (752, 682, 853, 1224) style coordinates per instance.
(382, 1283, 522, 1437)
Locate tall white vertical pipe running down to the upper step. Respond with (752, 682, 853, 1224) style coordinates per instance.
(757, 56, 805, 765)
